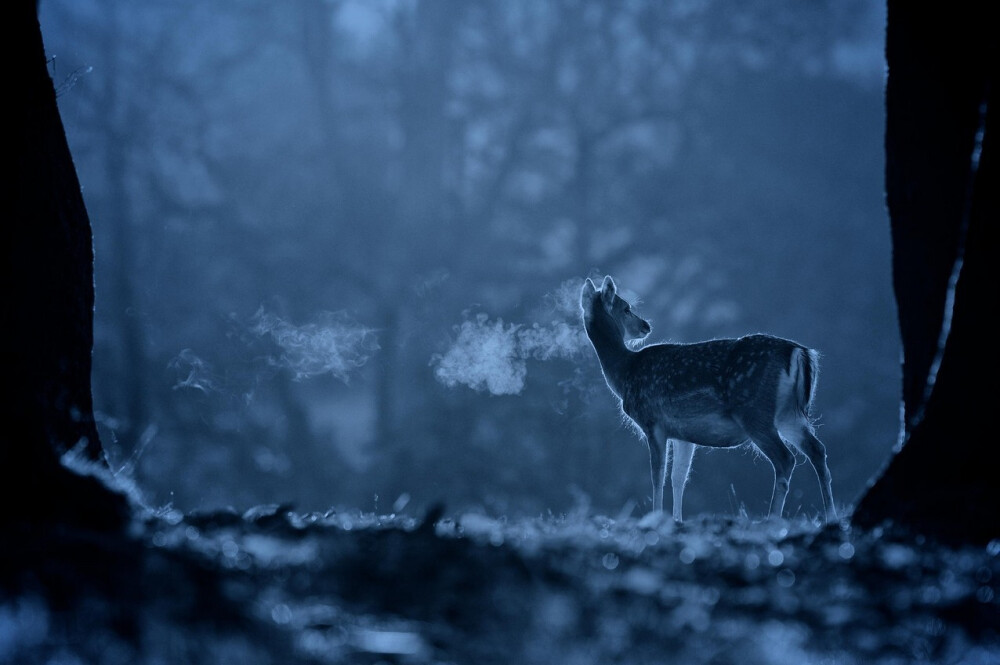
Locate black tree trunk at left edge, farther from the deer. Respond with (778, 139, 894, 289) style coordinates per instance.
(0, 0, 126, 525)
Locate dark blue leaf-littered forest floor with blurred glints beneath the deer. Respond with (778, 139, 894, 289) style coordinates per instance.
(0, 506, 1000, 665)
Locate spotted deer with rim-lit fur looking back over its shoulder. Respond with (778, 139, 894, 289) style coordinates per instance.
(580, 275, 837, 523)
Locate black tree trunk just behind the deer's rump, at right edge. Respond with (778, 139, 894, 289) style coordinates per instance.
(853, 0, 1000, 543)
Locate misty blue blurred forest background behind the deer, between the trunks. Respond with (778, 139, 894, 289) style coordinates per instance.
(40, 0, 900, 516)
